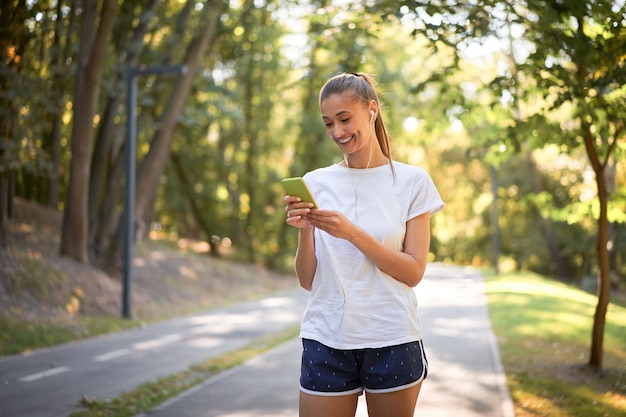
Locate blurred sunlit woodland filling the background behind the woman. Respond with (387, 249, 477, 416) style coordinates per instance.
(0, 0, 626, 290)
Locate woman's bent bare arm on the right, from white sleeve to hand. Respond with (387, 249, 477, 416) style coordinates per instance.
(305, 210, 430, 287)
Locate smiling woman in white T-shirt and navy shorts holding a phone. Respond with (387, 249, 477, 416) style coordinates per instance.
(285, 74, 443, 417)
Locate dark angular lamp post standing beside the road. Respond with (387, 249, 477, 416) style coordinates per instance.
(122, 65, 187, 319)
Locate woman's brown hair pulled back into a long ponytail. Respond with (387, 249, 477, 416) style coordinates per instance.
(319, 73, 393, 170)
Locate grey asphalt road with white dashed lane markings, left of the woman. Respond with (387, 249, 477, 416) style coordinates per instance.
(0, 289, 307, 417)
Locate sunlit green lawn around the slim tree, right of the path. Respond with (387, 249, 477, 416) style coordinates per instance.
(485, 273, 626, 417)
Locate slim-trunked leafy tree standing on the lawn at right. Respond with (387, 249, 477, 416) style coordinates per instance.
(382, 0, 626, 368)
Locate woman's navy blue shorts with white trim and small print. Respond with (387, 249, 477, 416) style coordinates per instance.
(300, 339, 428, 396)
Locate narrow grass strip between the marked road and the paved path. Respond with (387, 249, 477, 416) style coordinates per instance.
(70, 325, 300, 417)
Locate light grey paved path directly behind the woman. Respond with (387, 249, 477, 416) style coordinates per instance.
(140, 264, 514, 417)
